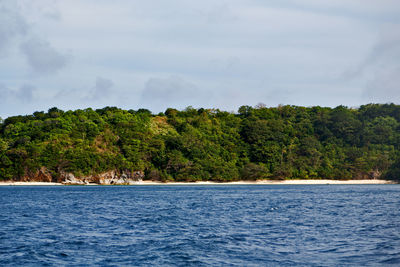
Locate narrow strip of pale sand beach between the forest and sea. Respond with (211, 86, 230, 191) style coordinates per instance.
(0, 179, 398, 186)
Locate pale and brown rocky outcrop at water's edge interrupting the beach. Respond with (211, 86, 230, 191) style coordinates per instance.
(59, 171, 144, 185)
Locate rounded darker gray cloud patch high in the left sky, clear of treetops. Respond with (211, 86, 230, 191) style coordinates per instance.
(20, 38, 69, 73)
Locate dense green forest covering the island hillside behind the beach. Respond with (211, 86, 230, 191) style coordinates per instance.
(0, 104, 400, 181)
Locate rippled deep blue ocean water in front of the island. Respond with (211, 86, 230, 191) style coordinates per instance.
(0, 185, 400, 266)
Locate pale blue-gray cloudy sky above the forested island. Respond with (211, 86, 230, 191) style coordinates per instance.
(0, 0, 400, 119)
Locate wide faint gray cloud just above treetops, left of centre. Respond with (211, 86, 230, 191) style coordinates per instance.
(141, 76, 204, 111)
